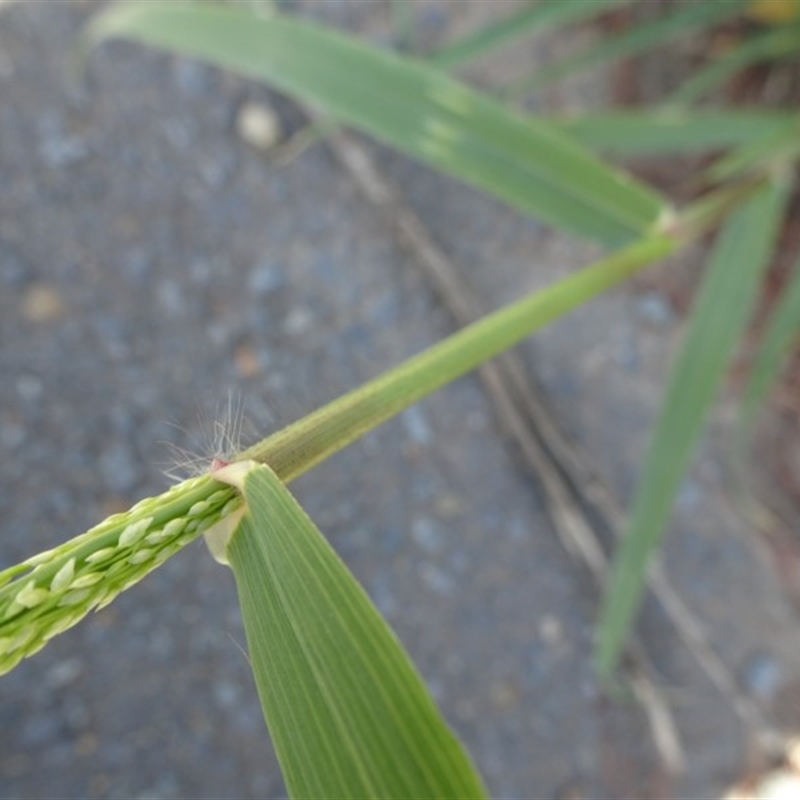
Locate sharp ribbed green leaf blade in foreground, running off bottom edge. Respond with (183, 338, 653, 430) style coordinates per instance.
(228, 464, 486, 798)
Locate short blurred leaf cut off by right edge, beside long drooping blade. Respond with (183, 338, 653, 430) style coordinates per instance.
(739, 247, 800, 435)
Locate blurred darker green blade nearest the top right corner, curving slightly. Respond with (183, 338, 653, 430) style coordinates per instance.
(667, 19, 800, 105)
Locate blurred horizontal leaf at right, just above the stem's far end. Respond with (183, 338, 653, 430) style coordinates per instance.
(551, 109, 800, 156)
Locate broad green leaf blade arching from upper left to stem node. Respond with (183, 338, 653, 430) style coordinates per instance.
(88, 2, 668, 245)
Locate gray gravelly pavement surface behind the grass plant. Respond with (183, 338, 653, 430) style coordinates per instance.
(0, 2, 800, 799)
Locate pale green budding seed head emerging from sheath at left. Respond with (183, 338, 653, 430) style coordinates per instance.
(0, 477, 241, 675)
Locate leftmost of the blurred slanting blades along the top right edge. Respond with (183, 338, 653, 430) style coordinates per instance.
(429, 0, 631, 69)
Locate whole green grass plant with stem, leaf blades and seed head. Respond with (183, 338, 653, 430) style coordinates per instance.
(0, 0, 800, 797)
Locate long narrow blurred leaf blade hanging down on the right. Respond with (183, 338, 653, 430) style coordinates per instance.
(595, 178, 787, 677)
